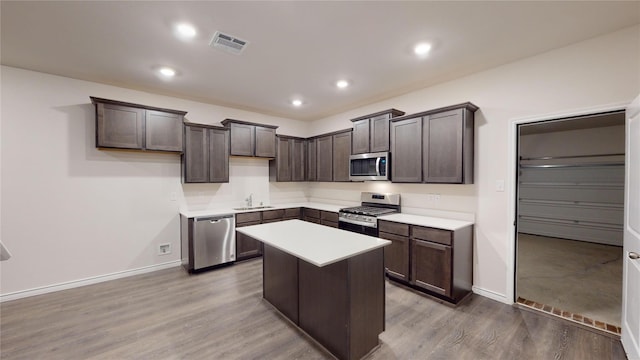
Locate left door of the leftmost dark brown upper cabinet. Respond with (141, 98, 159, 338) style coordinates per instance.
(96, 104, 145, 149)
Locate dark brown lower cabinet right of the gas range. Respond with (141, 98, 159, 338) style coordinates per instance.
(378, 220, 473, 303)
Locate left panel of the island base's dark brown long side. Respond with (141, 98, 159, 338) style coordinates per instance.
(262, 245, 298, 324)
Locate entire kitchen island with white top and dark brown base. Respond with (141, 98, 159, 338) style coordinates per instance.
(237, 220, 391, 359)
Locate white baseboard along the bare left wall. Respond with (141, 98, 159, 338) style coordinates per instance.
(0, 259, 182, 303)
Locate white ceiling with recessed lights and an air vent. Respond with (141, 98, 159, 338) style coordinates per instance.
(0, 0, 640, 120)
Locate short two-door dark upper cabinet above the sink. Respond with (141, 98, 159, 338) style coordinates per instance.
(222, 119, 278, 158)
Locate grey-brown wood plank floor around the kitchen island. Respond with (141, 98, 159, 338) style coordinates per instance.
(0, 259, 625, 360)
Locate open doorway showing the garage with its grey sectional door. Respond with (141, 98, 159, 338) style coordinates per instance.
(515, 111, 625, 335)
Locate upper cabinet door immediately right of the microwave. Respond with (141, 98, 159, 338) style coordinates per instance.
(391, 117, 422, 183)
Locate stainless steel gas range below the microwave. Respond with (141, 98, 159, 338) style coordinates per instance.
(338, 192, 400, 232)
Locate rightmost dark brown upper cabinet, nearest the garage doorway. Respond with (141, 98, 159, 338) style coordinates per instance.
(422, 107, 474, 184)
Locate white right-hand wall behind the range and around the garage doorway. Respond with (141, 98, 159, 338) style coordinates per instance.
(310, 26, 640, 302)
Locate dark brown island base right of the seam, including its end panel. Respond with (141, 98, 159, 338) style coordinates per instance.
(298, 249, 385, 359)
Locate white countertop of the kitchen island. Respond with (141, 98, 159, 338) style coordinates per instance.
(236, 220, 391, 266)
